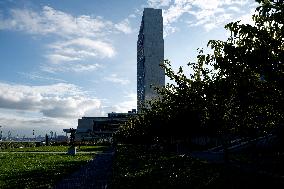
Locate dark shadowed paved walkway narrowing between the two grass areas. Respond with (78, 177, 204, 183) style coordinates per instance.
(53, 149, 114, 189)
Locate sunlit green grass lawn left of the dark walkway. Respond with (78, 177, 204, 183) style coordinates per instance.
(0, 146, 106, 189)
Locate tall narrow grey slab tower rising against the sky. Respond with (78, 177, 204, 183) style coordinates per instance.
(137, 8, 165, 112)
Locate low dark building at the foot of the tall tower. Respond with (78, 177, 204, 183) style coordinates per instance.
(75, 109, 136, 141)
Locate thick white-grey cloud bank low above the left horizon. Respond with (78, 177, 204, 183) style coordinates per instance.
(0, 83, 101, 118)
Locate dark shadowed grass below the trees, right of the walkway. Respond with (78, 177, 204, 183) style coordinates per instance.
(112, 145, 284, 189)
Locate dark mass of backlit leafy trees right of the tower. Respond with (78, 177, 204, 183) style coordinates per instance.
(116, 0, 284, 143)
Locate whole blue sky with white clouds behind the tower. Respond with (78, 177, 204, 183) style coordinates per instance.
(0, 0, 257, 137)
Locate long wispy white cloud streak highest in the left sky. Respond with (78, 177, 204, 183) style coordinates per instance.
(1, 6, 113, 38)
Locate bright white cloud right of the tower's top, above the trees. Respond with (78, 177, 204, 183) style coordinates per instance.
(148, 0, 256, 36)
